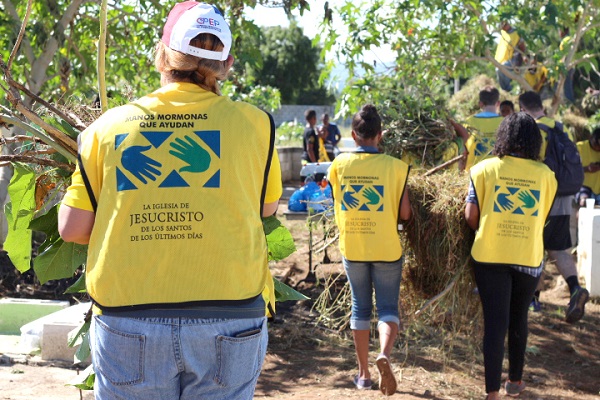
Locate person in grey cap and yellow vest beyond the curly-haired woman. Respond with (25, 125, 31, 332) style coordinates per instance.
(450, 86, 503, 171)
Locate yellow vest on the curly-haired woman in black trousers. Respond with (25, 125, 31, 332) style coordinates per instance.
(471, 156, 557, 268)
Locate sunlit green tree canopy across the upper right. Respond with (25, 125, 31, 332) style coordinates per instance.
(320, 0, 600, 117)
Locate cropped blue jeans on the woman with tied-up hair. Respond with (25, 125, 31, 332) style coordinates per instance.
(343, 258, 403, 330)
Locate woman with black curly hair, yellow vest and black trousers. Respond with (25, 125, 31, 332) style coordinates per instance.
(465, 112, 557, 400)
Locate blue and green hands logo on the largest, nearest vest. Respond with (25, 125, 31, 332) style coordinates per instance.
(115, 131, 221, 191)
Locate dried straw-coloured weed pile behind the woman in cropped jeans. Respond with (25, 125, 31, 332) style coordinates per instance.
(314, 172, 482, 340)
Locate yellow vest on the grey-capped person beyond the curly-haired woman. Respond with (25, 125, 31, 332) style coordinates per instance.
(465, 115, 504, 171)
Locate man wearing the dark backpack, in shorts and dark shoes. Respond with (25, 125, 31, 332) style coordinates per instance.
(519, 91, 590, 323)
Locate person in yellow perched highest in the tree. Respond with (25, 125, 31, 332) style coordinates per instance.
(494, 21, 526, 92)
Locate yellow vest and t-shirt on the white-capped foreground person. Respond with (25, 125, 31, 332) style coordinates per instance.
(63, 83, 282, 309)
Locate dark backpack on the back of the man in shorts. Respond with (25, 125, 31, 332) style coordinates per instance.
(538, 122, 583, 196)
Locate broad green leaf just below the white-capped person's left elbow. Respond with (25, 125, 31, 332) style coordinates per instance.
(33, 239, 87, 284)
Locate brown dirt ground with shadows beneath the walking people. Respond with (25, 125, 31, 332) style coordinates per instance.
(0, 203, 600, 400)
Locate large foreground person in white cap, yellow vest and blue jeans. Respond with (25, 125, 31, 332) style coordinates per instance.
(59, 1, 282, 400)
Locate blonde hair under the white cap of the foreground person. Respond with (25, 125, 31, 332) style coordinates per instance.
(154, 33, 229, 95)
